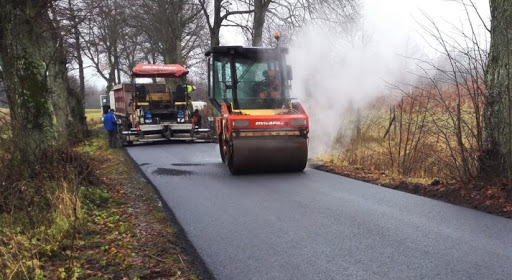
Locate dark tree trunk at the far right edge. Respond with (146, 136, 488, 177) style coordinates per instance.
(480, 0, 512, 178)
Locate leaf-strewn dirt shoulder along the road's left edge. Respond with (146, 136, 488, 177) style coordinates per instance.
(53, 130, 213, 279)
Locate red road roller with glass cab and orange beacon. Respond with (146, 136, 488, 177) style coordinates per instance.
(206, 34, 309, 175)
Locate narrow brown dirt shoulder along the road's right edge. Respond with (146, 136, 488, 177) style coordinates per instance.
(311, 163, 512, 218)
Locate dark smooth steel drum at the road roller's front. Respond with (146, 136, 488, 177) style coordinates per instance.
(228, 137, 308, 174)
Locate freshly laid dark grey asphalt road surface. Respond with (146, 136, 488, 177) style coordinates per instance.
(127, 144, 512, 279)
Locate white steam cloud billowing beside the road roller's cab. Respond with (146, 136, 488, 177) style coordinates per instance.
(288, 21, 414, 156)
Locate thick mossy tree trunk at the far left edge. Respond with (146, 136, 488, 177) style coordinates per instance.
(0, 1, 66, 168)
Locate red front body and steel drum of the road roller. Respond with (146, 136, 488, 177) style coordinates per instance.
(216, 103, 309, 175)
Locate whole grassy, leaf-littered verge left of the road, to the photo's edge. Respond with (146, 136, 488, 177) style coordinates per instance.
(0, 110, 199, 279)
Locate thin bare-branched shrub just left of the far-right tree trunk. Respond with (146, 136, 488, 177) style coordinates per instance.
(384, 6, 487, 181)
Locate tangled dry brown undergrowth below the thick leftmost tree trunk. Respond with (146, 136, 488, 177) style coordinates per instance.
(0, 128, 97, 279)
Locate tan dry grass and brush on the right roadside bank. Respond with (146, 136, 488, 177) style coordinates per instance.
(326, 90, 481, 184)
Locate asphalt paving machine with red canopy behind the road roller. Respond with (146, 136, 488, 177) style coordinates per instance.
(110, 64, 212, 145)
